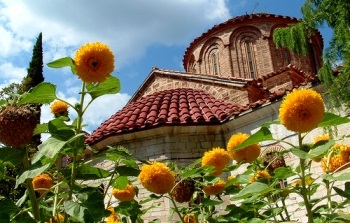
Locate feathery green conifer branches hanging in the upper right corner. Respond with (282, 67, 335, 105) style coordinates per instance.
(273, 0, 350, 109)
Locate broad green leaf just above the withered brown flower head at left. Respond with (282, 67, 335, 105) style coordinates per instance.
(18, 82, 57, 104)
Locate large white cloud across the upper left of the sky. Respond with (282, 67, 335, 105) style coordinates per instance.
(0, 0, 230, 66)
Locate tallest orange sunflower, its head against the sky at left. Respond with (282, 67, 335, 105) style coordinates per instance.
(74, 42, 114, 83)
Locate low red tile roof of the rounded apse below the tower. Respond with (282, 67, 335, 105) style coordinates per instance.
(86, 88, 249, 145)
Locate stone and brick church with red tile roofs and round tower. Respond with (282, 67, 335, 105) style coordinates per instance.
(86, 13, 348, 222)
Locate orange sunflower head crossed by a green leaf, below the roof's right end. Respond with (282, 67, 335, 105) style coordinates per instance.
(227, 132, 260, 163)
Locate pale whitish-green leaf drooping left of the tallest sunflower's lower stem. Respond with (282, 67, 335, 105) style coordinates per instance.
(32, 137, 66, 163)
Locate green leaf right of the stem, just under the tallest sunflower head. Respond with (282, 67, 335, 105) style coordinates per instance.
(86, 76, 120, 99)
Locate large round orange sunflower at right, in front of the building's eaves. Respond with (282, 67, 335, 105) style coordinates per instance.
(279, 89, 325, 133)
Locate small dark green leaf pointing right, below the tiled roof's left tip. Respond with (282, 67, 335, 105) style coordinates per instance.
(76, 164, 112, 180)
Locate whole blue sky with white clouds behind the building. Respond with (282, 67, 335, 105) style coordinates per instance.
(0, 0, 331, 131)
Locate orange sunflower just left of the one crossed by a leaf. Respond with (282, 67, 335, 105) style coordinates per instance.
(202, 147, 230, 176)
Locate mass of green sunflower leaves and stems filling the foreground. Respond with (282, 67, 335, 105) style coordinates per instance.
(0, 40, 350, 223)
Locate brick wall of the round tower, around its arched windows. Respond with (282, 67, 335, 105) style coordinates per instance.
(187, 22, 321, 78)
